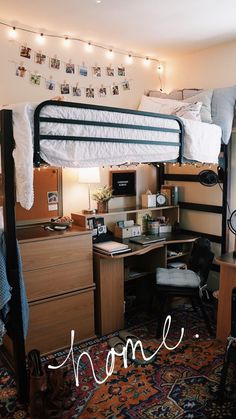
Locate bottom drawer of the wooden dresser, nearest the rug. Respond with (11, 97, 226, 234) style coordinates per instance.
(26, 289, 94, 354)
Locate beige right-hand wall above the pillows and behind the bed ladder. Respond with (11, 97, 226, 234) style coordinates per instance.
(166, 41, 236, 250)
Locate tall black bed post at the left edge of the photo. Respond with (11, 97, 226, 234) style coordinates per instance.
(0, 110, 27, 403)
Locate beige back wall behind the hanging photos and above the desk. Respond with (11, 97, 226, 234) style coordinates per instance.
(0, 26, 160, 214)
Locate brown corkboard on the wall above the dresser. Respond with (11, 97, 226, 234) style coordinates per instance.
(16, 167, 62, 225)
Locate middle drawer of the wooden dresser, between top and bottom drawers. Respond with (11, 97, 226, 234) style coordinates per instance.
(24, 259, 93, 301)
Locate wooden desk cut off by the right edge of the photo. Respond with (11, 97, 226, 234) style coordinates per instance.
(216, 252, 236, 341)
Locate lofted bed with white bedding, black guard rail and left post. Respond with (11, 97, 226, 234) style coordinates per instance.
(0, 101, 221, 400)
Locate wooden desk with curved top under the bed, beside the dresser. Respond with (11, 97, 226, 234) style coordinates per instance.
(94, 234, 196, 335)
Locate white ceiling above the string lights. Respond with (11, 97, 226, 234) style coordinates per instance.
(0, 0, 236, 59)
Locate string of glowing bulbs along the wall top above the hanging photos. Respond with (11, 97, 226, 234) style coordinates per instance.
(0, 21, 160, 65)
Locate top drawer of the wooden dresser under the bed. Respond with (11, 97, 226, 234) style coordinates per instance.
(20, 234, 92, 271)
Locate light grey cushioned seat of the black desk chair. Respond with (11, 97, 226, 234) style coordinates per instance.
(156, 268, 200, 288)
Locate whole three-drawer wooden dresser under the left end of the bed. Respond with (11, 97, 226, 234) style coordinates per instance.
(17, 226, 95, 354)
